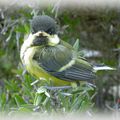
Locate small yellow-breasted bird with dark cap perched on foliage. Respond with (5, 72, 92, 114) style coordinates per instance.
(20, 15, 112, 86)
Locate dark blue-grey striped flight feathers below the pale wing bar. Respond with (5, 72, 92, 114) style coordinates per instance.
(53, 60, 96, 82)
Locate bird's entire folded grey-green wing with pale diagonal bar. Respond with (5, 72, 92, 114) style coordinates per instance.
(34, 45, 95, 82)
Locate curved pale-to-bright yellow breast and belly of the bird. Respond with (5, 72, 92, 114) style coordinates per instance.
(22, 47, 71, 86)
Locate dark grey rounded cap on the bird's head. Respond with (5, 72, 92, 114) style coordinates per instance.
(31, 15, 57, 35)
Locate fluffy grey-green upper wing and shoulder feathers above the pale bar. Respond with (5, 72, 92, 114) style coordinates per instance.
(33, 45, 73, 72)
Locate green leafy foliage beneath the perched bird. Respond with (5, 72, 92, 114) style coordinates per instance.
(0, 67, 95, 112)
